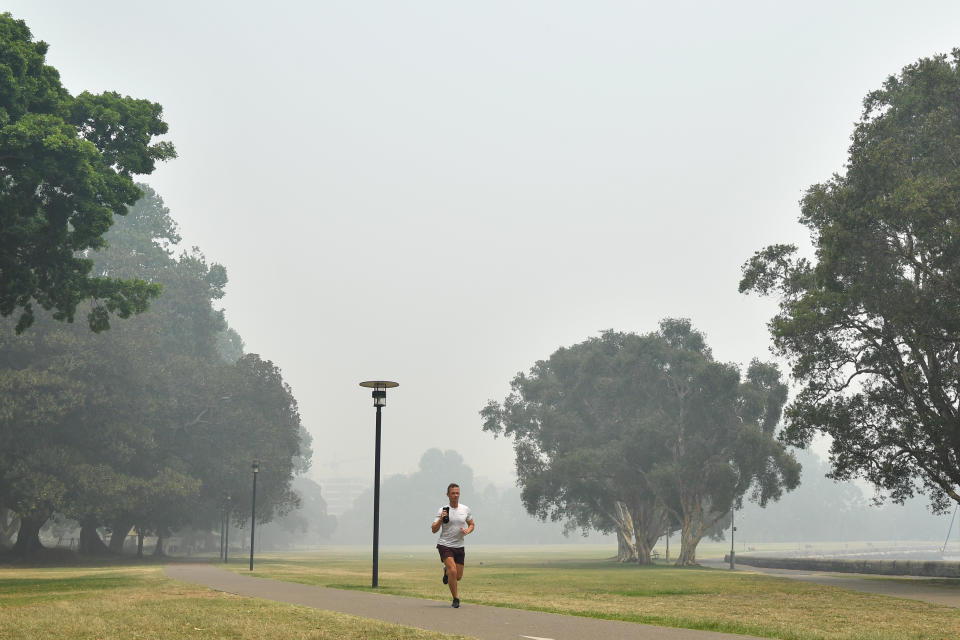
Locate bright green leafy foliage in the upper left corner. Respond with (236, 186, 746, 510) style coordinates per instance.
(0, 13, 176, 333)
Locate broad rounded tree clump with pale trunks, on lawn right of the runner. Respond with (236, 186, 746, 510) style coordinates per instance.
(481, 320, 799, 564)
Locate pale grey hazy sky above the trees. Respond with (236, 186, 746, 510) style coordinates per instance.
(5, 0, 960, 484)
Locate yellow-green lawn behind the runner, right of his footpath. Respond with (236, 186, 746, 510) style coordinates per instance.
(227, 545, 960, 640)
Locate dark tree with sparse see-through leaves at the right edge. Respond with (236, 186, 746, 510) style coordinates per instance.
(740, 50, 960, 509)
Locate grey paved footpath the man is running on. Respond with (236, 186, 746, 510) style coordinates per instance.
(164, 563, 764, 640)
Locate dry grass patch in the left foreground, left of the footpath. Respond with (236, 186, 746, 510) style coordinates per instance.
(0, 565, 462, 640)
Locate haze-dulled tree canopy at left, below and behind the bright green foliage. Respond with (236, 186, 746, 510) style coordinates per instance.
(0, 186, 310, 553)
